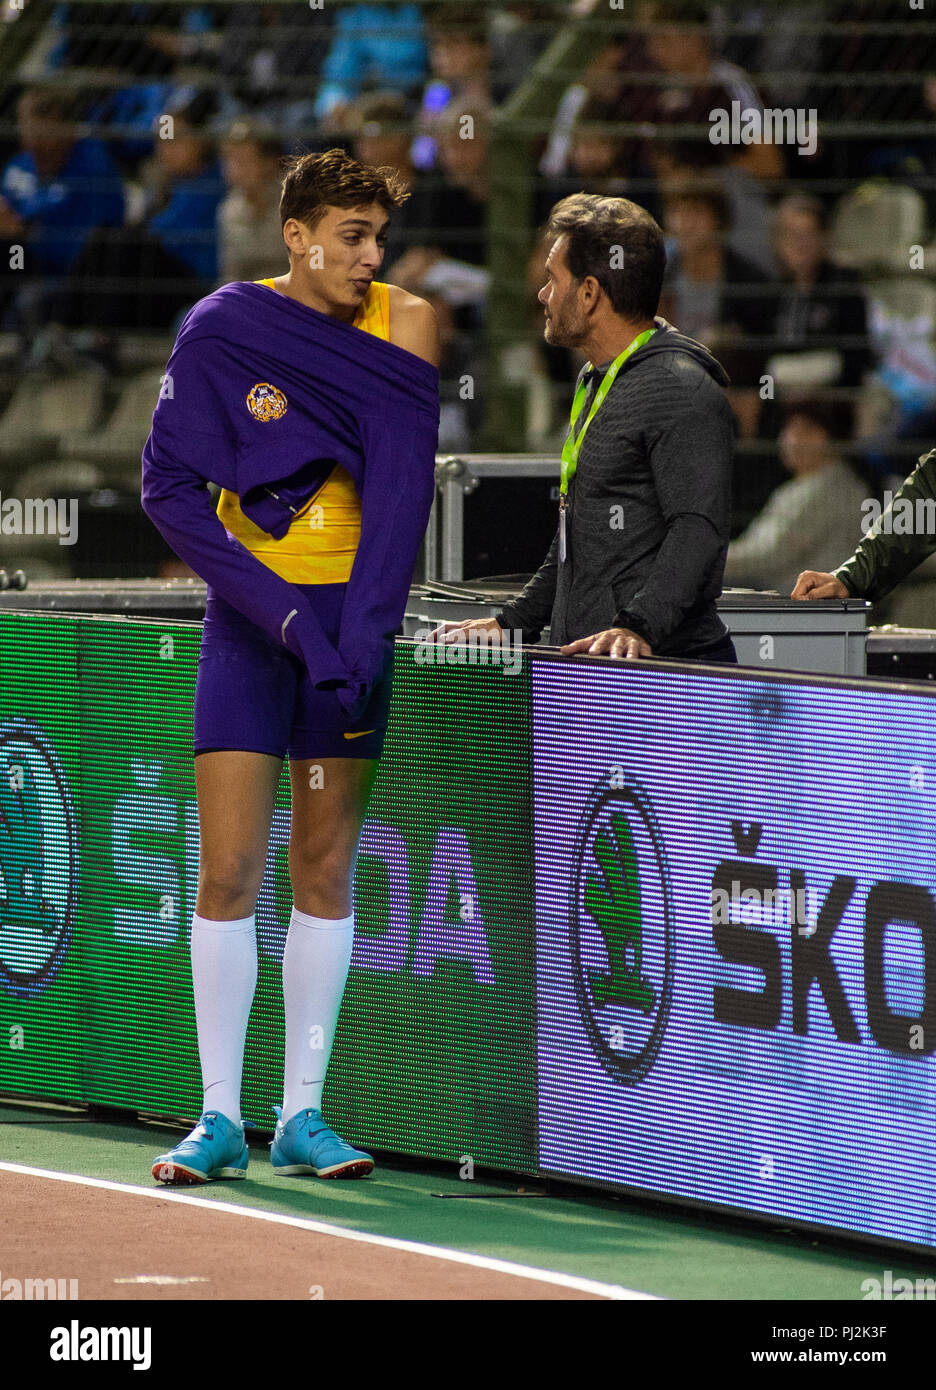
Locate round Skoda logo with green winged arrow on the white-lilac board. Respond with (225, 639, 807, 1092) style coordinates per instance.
(569, 774, 673, 1081)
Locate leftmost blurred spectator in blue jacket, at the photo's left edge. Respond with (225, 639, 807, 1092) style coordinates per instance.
(0, 86, 124, 335)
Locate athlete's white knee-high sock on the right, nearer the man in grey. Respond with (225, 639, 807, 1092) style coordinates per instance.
(282, 908, 355, 1122)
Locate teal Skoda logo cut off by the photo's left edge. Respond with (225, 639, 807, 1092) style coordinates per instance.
(0, 719, 78, 999)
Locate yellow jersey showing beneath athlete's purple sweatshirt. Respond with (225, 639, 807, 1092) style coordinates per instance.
(218, 279, 389, 584)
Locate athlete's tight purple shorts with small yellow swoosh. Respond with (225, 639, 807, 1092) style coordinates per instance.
(195, 584, 394, 759)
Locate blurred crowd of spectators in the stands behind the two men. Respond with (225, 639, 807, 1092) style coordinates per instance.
(0, 0, 936, 626)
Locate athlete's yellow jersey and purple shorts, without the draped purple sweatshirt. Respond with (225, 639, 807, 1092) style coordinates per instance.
(195, 279, 392, 759)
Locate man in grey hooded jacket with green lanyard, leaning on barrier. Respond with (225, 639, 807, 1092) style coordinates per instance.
(437, 193, 737, 662)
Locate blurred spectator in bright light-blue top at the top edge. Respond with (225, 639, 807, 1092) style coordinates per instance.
(314, 4, 428, 128)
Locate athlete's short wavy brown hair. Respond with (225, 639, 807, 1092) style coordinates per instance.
(280, 149, 410, 228)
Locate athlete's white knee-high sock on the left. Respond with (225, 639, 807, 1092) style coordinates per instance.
(192, 912, 257, 1125)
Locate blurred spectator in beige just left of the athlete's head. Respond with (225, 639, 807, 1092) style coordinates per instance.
(218, 121, 288, 285)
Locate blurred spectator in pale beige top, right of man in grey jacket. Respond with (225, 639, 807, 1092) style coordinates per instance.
(723, 399, 868, 595)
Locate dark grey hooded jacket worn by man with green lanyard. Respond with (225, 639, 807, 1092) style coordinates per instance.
(498, 318, 734, 656)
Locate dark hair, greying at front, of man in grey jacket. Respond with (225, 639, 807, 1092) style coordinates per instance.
(545, 193, 666, 321)
